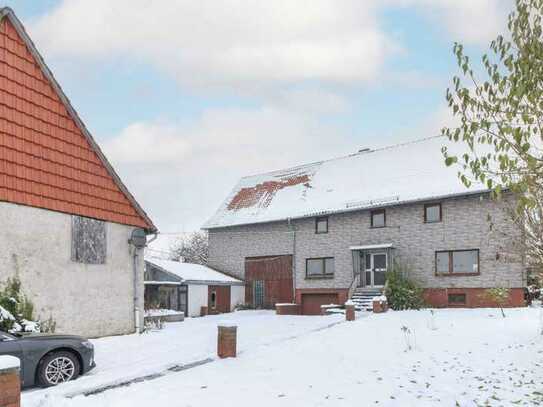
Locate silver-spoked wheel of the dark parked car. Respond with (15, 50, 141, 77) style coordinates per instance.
(38, 351, 79, 387)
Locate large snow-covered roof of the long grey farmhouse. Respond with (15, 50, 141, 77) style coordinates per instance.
(203, 137, 486, 229)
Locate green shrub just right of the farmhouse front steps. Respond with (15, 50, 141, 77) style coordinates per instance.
(385, 263, 424, 311)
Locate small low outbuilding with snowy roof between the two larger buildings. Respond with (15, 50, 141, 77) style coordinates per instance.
(145, 258, 245, 317)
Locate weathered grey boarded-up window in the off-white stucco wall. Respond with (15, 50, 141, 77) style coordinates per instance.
(72, 216, 107, 264)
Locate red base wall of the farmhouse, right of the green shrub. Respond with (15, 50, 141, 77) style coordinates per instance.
(423, 288, 526, 308)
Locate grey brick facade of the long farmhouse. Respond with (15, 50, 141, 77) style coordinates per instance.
(209, 194, 526, 310)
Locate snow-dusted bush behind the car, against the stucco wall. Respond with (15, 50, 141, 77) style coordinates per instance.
(0, 278, 40, 332)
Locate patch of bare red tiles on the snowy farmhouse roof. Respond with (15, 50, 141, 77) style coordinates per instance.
(227, 168, 314, 211)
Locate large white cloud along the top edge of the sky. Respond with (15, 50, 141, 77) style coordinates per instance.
(31, 0, 394, 88)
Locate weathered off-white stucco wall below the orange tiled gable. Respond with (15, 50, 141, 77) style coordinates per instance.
(0, 202, 143, 337)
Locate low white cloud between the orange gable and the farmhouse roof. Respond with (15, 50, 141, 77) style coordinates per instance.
(101, 108, 357, 232)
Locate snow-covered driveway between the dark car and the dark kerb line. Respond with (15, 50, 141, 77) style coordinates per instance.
(23, 311, 343, 407)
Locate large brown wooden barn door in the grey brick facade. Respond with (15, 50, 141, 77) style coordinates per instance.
(245, 255, 294, 309)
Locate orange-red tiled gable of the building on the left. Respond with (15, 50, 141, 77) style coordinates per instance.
(0, 8, 156, 232)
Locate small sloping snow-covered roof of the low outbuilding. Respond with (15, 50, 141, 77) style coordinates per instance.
(145, 258, 243, 285)
